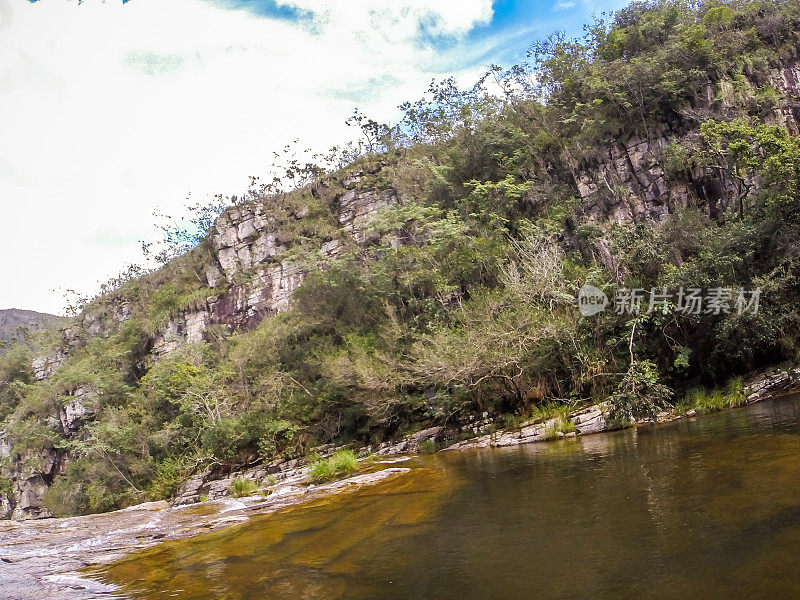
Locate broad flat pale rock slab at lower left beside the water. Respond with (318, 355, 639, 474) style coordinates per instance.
(0, 460, 410, 600)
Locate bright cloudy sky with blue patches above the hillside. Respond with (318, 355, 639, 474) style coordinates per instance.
(0, 0, 625, 314)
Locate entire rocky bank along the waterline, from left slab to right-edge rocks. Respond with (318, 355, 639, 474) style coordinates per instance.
(0, 366, 800, 600)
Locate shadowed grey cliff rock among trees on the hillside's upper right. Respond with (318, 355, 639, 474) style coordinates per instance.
(573, 59, 800, 223)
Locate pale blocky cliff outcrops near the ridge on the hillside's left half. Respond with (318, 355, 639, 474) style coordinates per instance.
(24, 164, 400, 366)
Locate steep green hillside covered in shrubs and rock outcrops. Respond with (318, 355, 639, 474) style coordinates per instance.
(0, 0, 800, 518)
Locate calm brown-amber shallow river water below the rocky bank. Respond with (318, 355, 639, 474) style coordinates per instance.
(101, 397, 800, 600)
